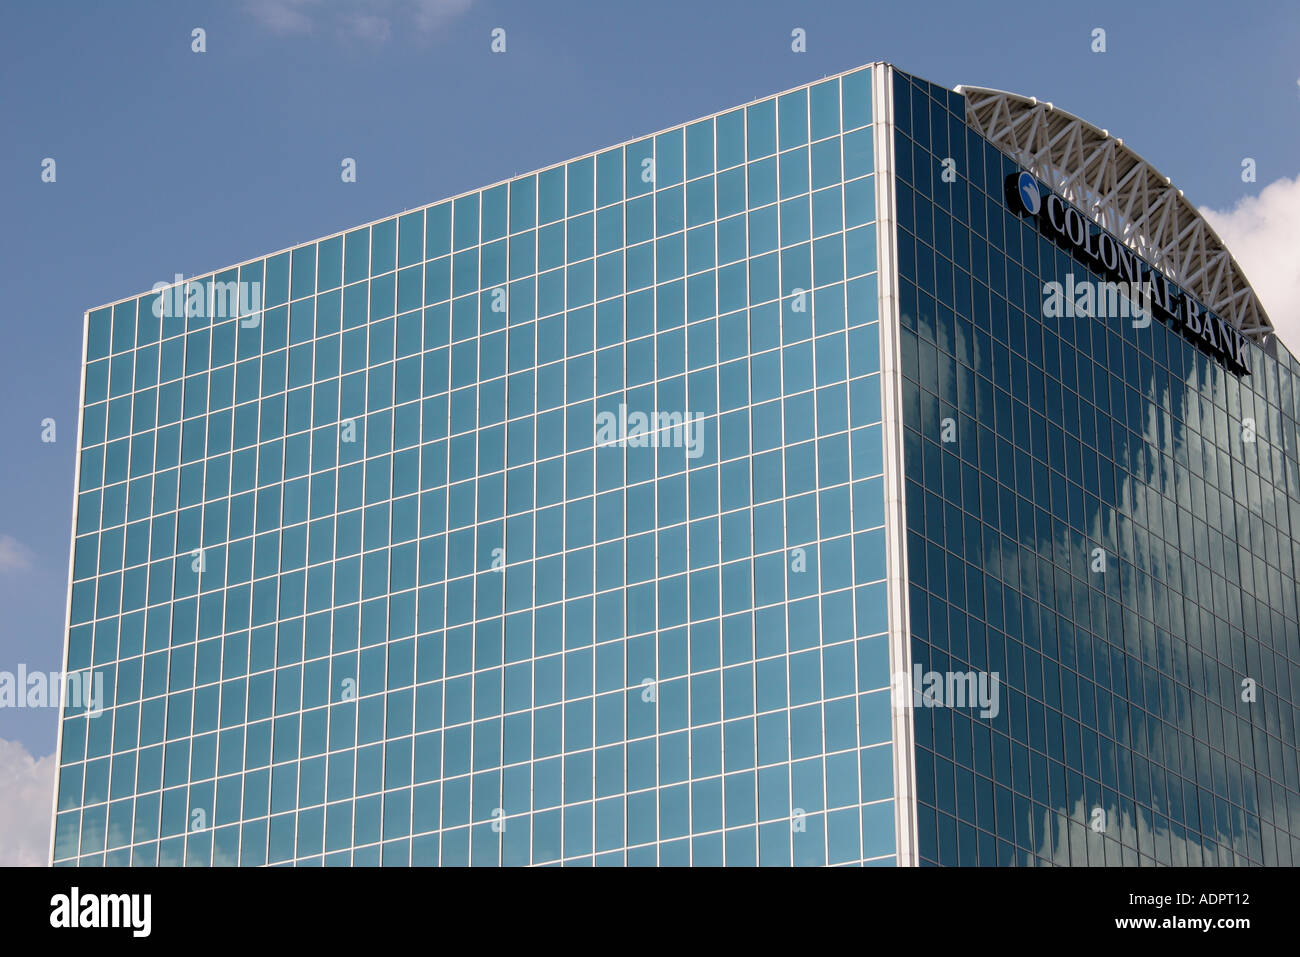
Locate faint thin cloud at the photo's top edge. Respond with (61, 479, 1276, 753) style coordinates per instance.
(247, 0, 473, 43)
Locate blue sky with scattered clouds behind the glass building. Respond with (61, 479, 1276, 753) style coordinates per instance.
(0, 0, 1300, 865)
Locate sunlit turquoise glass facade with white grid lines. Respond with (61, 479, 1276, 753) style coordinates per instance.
(53, 68, 896, 865)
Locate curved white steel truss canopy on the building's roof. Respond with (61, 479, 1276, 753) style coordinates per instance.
(956, 86, 1273, 341)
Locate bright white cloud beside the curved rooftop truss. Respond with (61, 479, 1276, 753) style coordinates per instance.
(1201, 176, 1300, 352)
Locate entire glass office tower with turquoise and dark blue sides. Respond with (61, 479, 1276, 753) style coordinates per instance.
(52, 64, 1300, 865)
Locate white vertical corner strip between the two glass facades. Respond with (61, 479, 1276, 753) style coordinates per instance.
(871, 59, 919, 866)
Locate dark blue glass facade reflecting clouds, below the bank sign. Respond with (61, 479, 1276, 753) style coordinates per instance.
(893, 72, 1300, 866)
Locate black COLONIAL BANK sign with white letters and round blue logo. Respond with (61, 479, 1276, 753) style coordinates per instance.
(1006, 173, 1252, 376)
